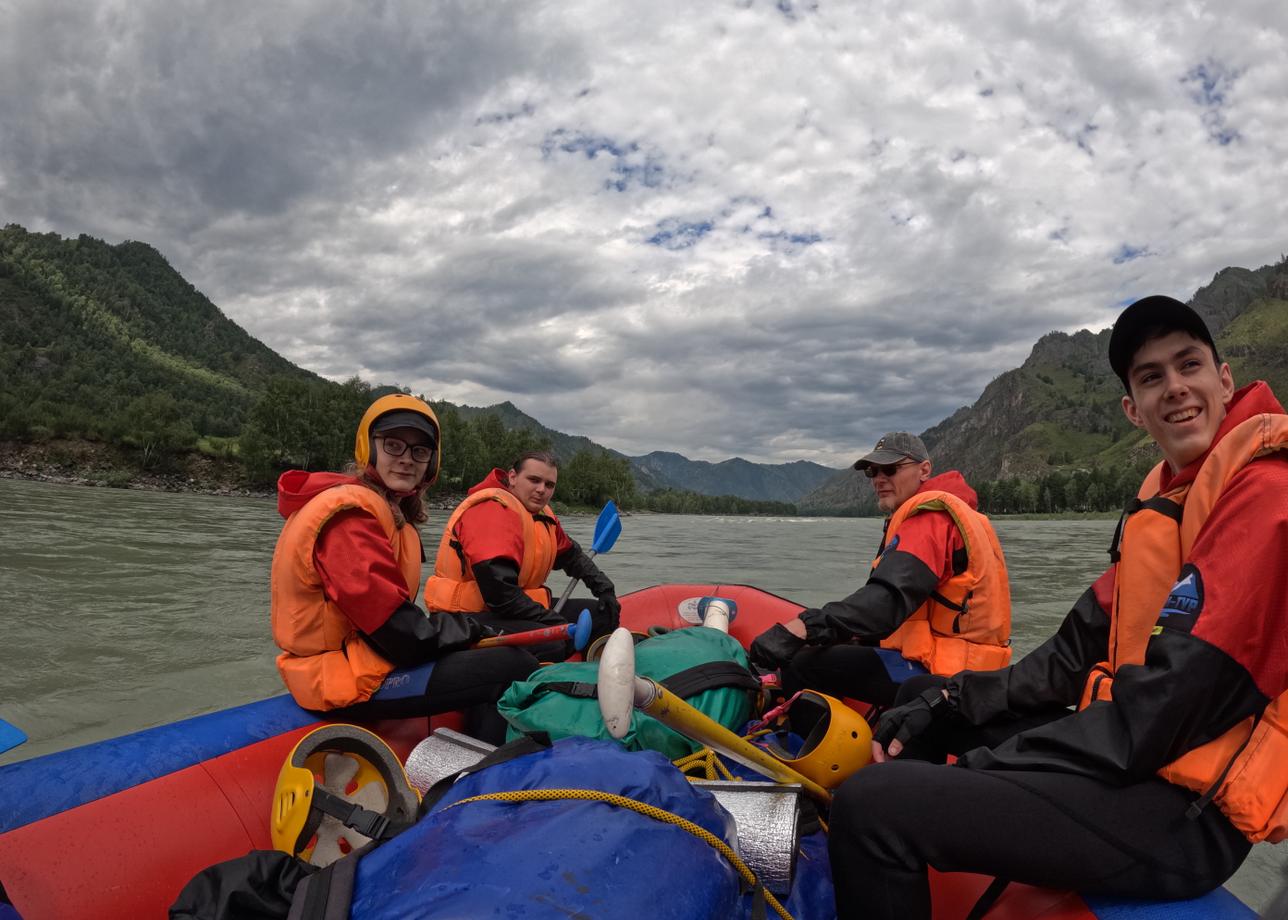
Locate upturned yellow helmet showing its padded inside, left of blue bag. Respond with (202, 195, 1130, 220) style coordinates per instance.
(269, 724, 420, 866)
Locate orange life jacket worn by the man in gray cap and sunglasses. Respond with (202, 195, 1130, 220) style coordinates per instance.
(872, 491, 1011, 675)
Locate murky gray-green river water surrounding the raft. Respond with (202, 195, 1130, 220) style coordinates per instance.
(0, 479, 1288, 906)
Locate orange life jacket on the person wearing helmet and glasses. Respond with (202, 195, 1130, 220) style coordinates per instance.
(270, 484, 421, 710)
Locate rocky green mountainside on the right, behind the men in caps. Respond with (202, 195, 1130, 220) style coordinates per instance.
(800, 260, 1288, 513)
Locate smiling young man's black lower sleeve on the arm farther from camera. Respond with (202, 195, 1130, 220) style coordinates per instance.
(948, 579, 1109, 725)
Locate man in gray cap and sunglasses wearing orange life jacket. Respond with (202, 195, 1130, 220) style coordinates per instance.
(751, 432, 1011, 706)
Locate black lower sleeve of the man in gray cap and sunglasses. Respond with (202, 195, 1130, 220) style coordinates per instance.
(800, 550, 940, 646)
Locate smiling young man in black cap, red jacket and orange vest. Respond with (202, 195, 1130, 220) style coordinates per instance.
(829, 296, 1288, 920)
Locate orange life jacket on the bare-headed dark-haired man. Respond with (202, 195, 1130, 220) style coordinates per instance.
(425, 488, 556, 613)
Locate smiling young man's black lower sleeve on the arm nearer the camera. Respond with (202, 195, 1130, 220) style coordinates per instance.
(958, 629, 1269, 785)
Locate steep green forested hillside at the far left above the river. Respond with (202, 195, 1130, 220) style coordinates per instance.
(0, 225, 311, 443)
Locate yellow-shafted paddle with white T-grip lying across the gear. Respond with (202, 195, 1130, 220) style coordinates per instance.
(596, 628, 832, 803)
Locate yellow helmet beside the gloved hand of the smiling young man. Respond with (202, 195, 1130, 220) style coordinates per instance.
(767, 691, 872, 789)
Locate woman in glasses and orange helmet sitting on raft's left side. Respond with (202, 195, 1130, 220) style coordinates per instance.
(272, 393, 537, 743)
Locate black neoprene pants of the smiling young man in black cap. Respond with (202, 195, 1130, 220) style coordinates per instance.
(828, 760, 1249, 920)
